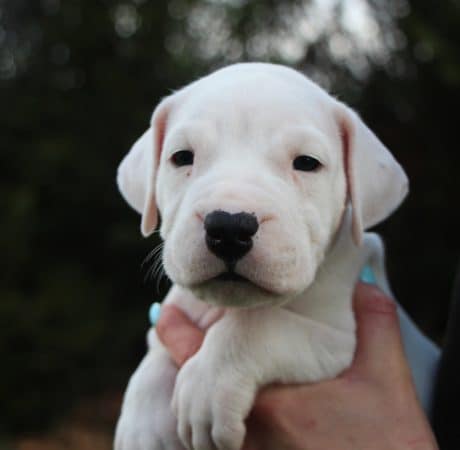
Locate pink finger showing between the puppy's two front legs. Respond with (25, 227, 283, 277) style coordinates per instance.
(156, 305, 204, 367)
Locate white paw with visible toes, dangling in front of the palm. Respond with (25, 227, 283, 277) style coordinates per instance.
(172, 354, 255, 450)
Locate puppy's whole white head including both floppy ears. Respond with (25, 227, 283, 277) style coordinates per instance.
(118, 63, 407, 306)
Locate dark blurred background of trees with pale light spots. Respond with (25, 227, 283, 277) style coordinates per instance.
(0, 0, 460, 450)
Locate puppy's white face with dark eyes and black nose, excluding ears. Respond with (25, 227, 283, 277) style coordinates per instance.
(157, 75, 346, 306)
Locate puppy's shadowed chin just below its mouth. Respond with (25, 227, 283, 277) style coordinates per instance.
(187, 278, 291, 308)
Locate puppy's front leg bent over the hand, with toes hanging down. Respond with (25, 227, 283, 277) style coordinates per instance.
(173, 308, 355, 450)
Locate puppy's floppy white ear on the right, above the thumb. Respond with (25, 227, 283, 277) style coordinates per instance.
(337, 104, 408, 245)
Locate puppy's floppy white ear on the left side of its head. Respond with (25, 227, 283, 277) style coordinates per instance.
(117, 97, 171, 237)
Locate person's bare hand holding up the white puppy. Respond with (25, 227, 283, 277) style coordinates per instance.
(157, 283, 438, 450)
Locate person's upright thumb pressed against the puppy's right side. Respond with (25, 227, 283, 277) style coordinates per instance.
(352, 283, 409, 382)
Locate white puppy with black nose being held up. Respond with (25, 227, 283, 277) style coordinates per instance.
(115, 63, 437, 450)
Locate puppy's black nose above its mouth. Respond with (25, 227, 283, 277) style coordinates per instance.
(204, 210, 259, 270)
